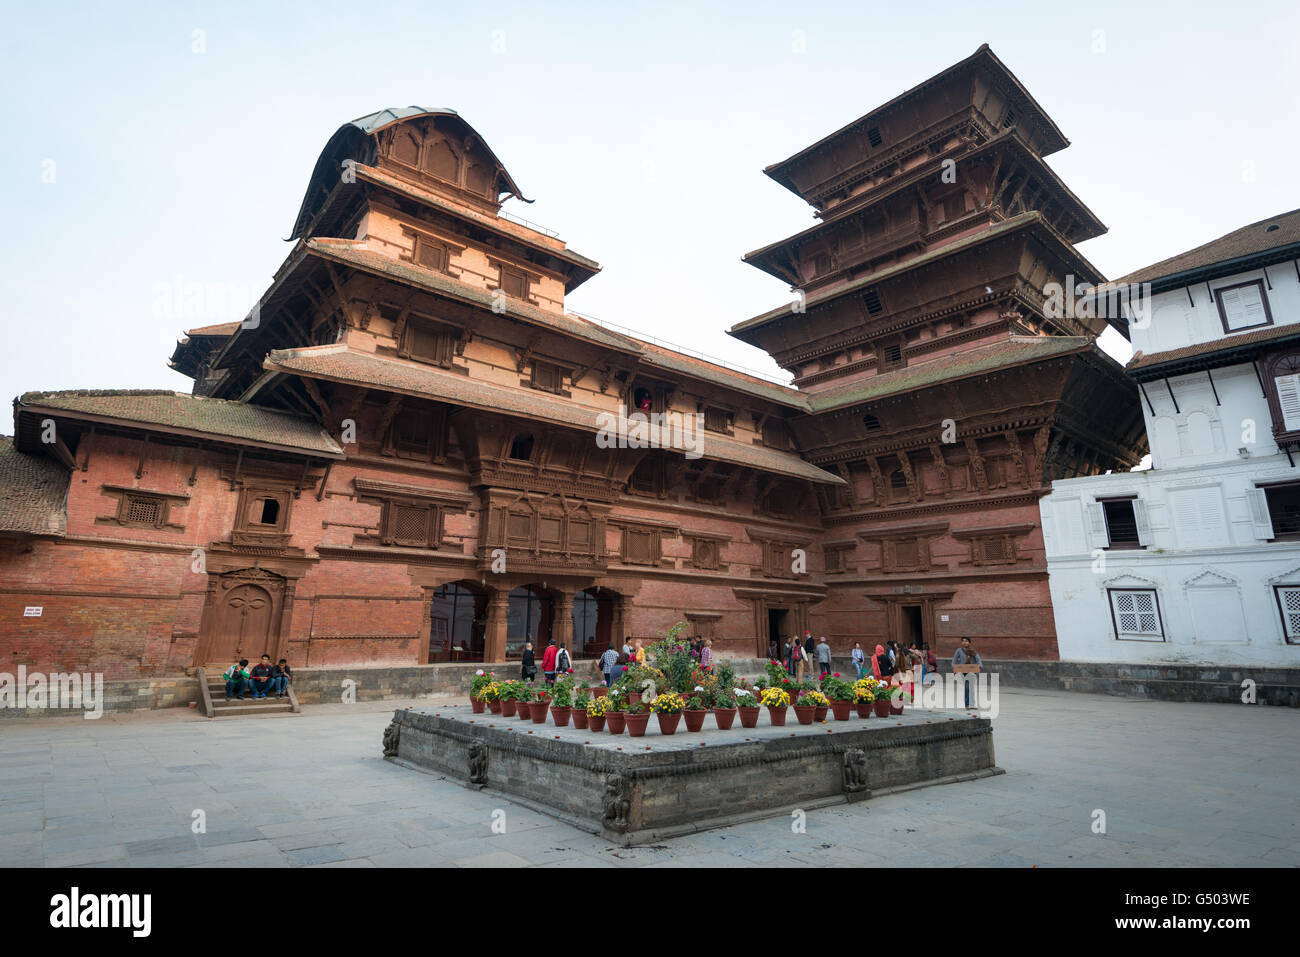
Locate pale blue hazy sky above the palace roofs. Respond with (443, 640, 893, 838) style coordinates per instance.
(0, 0, 1300, 405)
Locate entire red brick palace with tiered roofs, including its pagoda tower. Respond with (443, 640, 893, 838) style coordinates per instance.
(0, 47, 1145, 679)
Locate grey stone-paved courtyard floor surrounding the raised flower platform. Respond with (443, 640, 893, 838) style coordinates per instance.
(0, 690, 1300, 867)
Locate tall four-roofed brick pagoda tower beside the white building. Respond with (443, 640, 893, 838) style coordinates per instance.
(731, 46, 1147, 658)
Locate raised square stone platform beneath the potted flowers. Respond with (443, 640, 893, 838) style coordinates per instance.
(384, 703, 1001, 844)
